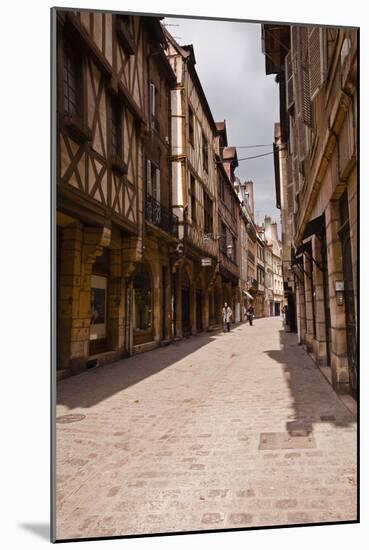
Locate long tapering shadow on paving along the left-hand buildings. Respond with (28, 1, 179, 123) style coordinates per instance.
(57, 325, 227, 409)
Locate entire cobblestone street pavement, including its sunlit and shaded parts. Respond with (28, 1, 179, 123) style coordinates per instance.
(57, 318, 356, 540)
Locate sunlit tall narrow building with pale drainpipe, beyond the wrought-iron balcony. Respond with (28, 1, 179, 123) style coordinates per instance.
(167, 33, 218, 337)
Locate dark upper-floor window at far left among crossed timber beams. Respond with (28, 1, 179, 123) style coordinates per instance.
(63, 44, 81, 115)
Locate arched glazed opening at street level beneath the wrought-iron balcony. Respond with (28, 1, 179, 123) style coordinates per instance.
(132, 264, 153, 345)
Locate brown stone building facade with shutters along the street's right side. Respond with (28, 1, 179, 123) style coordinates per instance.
(263, 25, 358, 396)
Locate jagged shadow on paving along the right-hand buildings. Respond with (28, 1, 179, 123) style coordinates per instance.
(264, 330, 356, 433)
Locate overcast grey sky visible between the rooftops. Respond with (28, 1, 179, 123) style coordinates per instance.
(164, 18, 280, 231)
